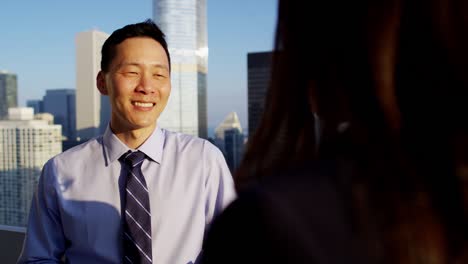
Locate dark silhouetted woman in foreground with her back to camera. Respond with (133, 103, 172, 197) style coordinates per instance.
(202, 0, 468, 263)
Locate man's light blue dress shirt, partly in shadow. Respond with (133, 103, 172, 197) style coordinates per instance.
(18, 127, 235, 264)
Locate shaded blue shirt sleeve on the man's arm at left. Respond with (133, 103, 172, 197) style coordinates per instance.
(18, 159, 66, 263)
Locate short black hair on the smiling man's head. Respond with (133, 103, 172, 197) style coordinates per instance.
(101, 19, 171, 72)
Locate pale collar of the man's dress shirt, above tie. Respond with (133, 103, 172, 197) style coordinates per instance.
(103, 125, 165, 165)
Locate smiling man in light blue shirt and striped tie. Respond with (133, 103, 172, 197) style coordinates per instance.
(19, 20, 235, 264)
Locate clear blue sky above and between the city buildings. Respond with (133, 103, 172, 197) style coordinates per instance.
(0, 0, 277, 134)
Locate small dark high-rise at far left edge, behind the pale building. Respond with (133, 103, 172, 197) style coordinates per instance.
(0, 71, 18, 120)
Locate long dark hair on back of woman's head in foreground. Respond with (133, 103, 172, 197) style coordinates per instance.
(236, 0, 468, 263)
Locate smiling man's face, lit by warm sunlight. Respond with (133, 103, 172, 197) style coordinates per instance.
(97, 37, 171, 133)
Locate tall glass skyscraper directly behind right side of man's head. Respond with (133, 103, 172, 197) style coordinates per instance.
(153, 0, 208, 138)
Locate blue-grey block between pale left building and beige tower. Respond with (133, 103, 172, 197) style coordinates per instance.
(42, 89, 76, 140)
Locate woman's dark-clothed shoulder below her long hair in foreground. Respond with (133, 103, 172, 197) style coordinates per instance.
(202, 164, 362, 263)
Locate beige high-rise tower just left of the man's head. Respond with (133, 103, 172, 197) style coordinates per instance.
(75, 30, 110, 140)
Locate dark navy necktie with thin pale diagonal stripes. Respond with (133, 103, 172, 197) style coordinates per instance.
(121, 150, 152, 264)
